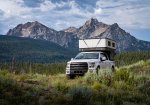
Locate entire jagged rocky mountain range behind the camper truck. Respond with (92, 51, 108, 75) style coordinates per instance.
(6, 18, 150, 52)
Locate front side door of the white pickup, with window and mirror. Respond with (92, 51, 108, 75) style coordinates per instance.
(100, 53, 110, 69)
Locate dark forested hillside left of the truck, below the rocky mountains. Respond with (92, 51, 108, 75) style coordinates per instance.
(0, 35, 75, 63)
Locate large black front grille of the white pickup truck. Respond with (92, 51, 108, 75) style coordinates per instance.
(70, 62, 88, 73)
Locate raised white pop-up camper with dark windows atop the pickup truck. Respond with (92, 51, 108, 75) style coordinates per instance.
(79, 38, 116, 59)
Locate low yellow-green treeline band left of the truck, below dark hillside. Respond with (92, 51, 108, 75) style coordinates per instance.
(0, 62, 66, 75)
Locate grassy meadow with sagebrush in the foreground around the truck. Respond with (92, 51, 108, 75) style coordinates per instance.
(0, 60, 150, 105)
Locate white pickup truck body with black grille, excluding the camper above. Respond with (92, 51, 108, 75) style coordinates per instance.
(66, 51, 115, 78)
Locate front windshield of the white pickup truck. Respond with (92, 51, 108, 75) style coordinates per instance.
(75, 53, 99, 59)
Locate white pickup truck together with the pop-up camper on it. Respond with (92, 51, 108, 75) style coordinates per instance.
(66, 39, 116, 77)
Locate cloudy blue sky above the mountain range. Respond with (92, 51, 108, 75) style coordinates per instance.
(0, 0, 150, 41)
